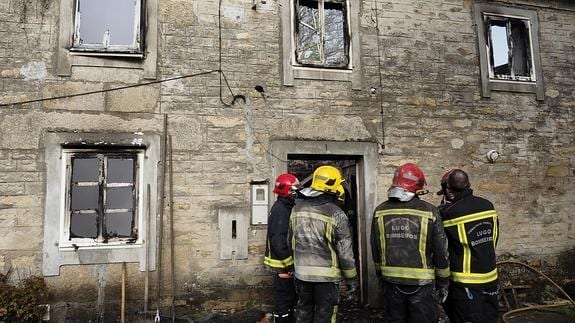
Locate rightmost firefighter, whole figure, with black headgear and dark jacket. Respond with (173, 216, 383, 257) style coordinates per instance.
(439, 169, 499, 323)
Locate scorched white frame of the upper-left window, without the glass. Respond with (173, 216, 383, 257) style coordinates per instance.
(70, 0, 146, 57)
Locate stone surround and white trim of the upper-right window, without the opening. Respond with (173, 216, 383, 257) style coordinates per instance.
(474, 3, 545, 101)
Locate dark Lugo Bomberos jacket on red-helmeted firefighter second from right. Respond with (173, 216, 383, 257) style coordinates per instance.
(371, 196, 449, 286)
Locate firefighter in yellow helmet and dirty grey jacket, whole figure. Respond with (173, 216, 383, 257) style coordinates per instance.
(288, 165, 358, 323)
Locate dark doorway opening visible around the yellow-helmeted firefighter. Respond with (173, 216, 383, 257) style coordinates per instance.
(287, 154, 365, 302)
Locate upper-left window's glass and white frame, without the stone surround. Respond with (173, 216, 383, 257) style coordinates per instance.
(72, 0, 142, 53)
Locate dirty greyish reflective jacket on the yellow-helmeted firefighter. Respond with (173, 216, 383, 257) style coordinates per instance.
(289, 193, 357, 282)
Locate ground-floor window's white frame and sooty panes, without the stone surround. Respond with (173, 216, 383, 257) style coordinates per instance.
(64, 150, 140, 244)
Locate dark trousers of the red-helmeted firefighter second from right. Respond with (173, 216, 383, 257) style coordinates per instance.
(381, 281, 438, 323)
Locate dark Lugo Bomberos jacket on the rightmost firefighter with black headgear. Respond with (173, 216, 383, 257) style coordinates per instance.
(439, 189, 499, 288)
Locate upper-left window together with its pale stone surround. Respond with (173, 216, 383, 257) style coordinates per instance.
(57, 0, 159, 79)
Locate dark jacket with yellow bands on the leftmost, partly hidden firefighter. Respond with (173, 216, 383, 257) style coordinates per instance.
(264, 196, 294, 272)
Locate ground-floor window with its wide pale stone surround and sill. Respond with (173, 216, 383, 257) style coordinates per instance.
(42, 132, 161, 276)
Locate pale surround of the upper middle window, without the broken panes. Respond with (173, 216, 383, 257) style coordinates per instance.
(281, 0, 362, 90)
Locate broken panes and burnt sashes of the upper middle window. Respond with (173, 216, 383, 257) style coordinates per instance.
(294, 0, 350, 68)
